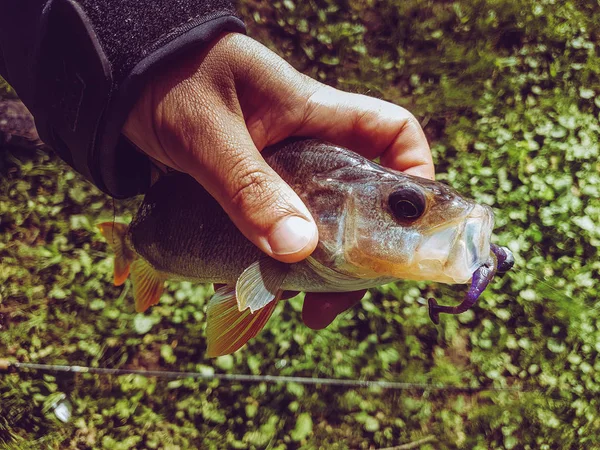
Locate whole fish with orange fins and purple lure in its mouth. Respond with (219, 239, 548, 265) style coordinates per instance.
(99, 138, 514, 357)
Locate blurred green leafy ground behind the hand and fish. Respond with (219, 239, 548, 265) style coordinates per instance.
(0, 0, 600, 450)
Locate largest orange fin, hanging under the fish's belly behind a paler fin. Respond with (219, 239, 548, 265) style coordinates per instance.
(206, 285, 282, 358)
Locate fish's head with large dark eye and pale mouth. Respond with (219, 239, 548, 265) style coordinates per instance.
(341, 169, 494, 284)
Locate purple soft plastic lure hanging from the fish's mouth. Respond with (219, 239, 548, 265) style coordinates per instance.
(429, 244, 515, 325)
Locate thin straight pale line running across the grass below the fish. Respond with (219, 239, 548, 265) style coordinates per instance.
(0, 359, 534, 393)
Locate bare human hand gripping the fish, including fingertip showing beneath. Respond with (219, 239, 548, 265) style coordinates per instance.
(123, 33, 434, 329)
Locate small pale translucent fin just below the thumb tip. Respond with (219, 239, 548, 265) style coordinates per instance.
(235, 256, 290, 313)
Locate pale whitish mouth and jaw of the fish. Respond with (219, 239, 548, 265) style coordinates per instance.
(413, 204, 494, 284)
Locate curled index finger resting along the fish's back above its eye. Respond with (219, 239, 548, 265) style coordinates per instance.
(294, 85, 435, 179)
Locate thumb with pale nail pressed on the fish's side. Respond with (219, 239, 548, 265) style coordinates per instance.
(188, 120, 318, 263)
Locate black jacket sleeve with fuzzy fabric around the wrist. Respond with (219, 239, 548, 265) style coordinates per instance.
(0, 0, 245, 198)
